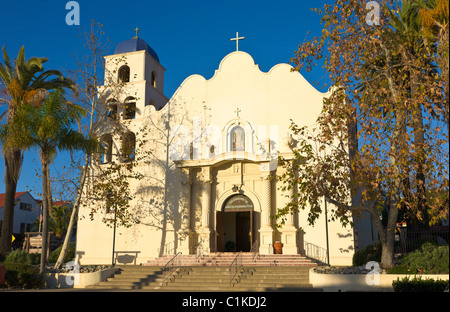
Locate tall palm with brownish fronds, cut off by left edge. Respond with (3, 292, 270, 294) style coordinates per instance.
(0, 47, 76, 255)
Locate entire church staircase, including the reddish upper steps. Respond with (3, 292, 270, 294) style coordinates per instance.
(90, 253, 320, 292)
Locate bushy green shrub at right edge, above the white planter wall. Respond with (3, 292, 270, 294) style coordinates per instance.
(401, 242, 449, 274)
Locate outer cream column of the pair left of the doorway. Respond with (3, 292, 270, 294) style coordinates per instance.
(177, 168, 194, 255)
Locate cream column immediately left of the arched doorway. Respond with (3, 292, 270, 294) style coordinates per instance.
(198, 167, 212, 253)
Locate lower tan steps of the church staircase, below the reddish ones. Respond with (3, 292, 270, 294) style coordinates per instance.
(89, 266, 318, 292)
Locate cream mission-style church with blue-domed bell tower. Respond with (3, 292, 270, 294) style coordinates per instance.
(76, 36, 374, 265)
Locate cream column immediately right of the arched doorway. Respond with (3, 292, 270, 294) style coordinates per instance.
(259, 171, 273, 254)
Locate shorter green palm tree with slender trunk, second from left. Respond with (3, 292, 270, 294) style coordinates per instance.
(8, 89, 91, 273)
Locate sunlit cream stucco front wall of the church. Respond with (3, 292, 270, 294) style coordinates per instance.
(77, 52, 368, 265)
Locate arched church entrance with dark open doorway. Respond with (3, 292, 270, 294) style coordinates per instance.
(216, 194, 256, 252)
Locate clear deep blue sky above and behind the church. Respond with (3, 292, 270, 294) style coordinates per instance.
(0, 0, 326, 198)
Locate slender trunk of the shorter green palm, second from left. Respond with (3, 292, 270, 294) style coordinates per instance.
(39, 152, 50, 274)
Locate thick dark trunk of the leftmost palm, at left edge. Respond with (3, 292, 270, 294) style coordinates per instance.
(0, 150, 23, 255)
